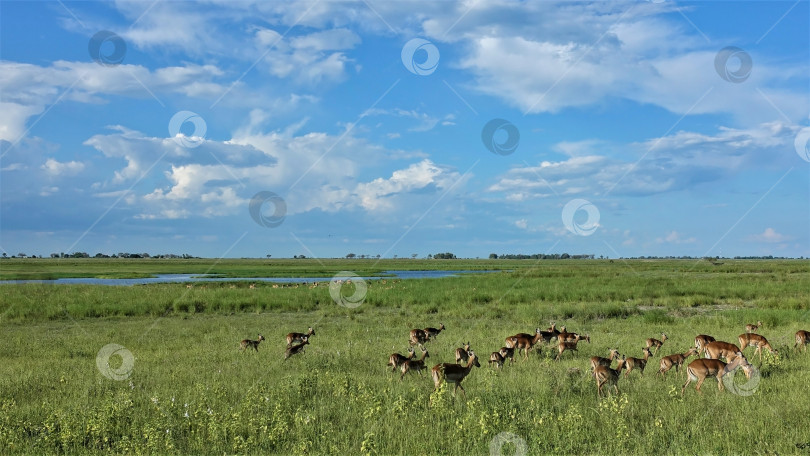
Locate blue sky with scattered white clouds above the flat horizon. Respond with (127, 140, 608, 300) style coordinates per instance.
(0, 0, 810, 258)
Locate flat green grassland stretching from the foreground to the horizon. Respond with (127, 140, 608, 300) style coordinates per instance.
(0, 259, 810, 455)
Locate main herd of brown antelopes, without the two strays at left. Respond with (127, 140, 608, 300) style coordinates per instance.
(388, 322, 810, 396)
